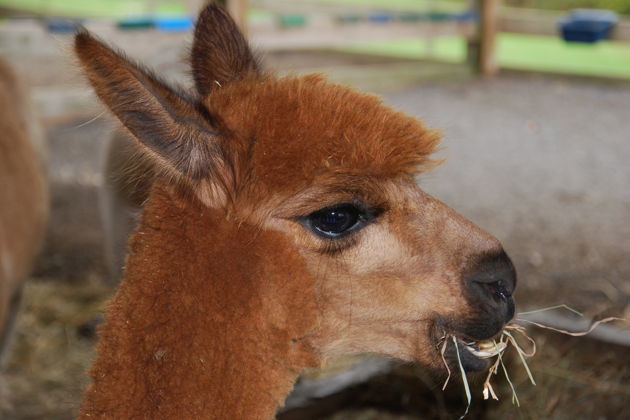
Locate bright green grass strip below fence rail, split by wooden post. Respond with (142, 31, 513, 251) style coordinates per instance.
(344, 33, 630, 78)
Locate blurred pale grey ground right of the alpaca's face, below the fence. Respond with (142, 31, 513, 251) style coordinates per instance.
(386, 75, 630, 312)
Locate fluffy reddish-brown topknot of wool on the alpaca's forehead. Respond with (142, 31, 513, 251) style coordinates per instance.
(204, 74, 440, 189)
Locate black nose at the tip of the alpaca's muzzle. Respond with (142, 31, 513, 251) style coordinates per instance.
(467, 251, 516, 319)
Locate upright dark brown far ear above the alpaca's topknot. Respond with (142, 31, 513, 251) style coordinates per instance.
(191, 4, 259, 96)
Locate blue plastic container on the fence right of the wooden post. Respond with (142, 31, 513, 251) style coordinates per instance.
(558, 9, 619, 43)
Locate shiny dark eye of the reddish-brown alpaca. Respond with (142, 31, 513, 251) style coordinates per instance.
(305, 204, 364, 238)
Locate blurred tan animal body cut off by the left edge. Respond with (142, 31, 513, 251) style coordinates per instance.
(0, 58, 49, 364)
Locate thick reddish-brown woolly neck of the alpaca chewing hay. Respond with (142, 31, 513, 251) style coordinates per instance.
(81, 188, 318, 419)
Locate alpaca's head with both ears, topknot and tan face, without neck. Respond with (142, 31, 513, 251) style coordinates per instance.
(75, 5, 515, 369)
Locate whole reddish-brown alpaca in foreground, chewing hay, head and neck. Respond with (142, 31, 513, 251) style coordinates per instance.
(75, 5, 516, 419)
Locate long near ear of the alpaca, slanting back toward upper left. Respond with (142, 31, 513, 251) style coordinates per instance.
(74, 32, 232, 204)
